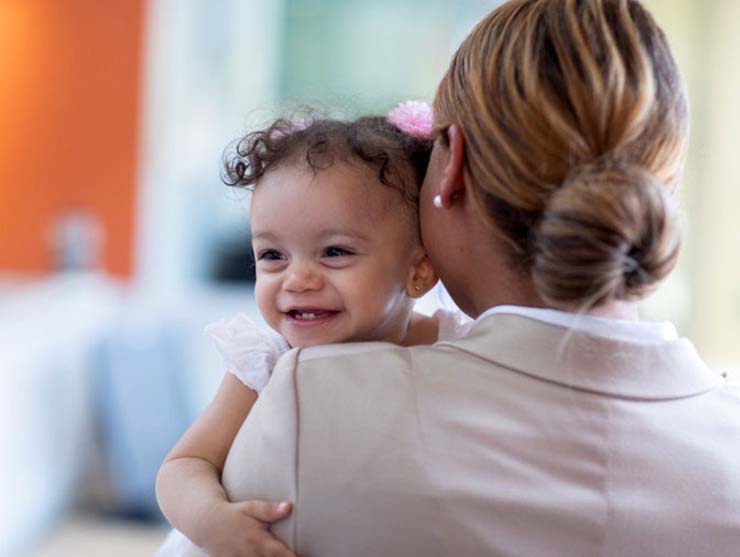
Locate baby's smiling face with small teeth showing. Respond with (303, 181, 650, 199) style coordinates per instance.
(251, 159, 423, 347)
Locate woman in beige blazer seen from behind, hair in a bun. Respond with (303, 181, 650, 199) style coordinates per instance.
(215, 0, 740, 557)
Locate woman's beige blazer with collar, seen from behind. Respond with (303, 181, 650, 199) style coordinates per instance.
(224, 312, 740, 557)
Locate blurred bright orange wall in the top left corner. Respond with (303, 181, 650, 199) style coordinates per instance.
(0, 0, 145, 276)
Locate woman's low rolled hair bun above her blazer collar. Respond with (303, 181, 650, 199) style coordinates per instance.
(531, 160, 681, 311)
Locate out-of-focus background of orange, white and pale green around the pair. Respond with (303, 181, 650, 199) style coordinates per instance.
(0, 0, 740, 557)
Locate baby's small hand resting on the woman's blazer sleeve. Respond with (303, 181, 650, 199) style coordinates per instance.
(203, 501, 297, 557)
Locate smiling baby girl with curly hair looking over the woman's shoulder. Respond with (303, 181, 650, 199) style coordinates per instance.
(157, 103, 467, 556)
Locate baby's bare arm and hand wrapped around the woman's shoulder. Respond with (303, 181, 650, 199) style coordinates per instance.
(157, 373, 295, 557)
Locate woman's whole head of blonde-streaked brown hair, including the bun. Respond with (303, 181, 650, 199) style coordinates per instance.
(434, 0, 688, 311)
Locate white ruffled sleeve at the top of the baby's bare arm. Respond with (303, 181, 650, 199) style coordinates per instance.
(205, 313, 290, 392)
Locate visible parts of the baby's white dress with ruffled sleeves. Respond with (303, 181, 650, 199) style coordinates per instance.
(154, 309, 474, 557)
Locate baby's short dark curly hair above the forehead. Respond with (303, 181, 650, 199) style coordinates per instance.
(222, 116, 432, 208)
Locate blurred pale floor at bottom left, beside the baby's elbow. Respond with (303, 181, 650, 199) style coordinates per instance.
(30, 515, 167, 557)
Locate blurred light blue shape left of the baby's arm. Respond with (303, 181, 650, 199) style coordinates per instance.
(93, 319, 189, 519)
